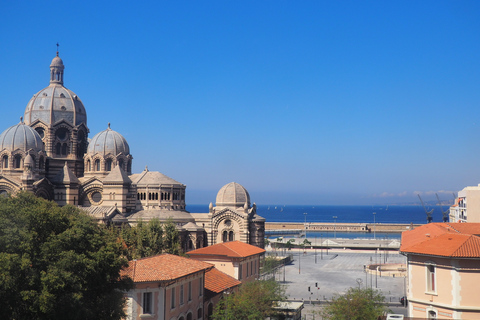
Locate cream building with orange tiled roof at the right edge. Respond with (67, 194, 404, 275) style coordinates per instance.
(400, 223, 480, 320)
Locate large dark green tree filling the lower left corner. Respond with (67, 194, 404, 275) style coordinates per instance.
(0, 193, 132, 320)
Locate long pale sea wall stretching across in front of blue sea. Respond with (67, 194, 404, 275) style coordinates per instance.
(265, 222, 421, 232)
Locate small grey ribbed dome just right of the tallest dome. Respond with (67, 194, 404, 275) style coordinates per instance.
(87, 123, 130, 156)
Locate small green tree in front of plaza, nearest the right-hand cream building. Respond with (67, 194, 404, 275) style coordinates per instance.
(322, 288, 389, 320)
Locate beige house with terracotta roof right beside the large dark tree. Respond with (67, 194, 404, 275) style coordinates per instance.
(122, 254, 240, 320)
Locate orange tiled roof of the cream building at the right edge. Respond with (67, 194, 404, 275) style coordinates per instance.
(400, 223, 480, 258)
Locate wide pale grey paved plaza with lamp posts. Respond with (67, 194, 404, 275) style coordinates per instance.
(267, 249, 406, 319)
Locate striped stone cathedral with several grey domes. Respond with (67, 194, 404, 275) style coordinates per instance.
(0, 52, 265, 251)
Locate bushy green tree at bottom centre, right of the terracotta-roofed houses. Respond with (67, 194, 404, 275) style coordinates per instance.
(212, 280, 285, 320)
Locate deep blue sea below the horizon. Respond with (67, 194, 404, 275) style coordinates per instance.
(187, 205, 449, 238)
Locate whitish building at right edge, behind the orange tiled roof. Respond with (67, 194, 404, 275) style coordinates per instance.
(450, 185, 480, 222)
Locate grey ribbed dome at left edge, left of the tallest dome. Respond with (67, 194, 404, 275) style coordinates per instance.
(0, 122, 43, 152)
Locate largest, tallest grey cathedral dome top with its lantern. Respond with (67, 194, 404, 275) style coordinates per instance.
(24, 56, 87, 126)
